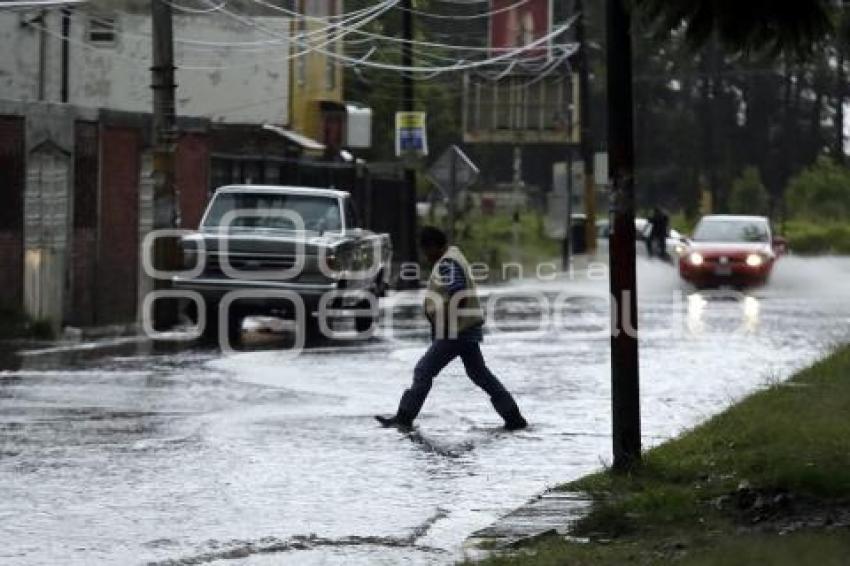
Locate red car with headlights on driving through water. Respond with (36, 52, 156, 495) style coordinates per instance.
(679, 215, 785, 287)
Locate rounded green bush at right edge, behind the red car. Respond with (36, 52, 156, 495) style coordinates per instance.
(786, 157, 850, 222)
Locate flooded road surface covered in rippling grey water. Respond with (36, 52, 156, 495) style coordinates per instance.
(0, 258, 850, 565)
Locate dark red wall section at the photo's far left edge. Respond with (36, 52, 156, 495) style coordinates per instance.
(0, 116, 25, 310)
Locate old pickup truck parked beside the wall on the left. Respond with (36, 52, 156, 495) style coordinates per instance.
(172, 185, 392, 340)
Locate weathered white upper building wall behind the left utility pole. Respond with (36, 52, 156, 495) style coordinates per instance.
(0, 10, 289, 124)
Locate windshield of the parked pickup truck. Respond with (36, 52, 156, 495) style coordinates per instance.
(204, 193, 342, 232)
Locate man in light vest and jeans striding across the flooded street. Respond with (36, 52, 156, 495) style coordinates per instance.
(375, 227, 528, 430)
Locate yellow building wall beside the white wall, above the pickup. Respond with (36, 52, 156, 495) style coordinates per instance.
(289, 0, 343, 140)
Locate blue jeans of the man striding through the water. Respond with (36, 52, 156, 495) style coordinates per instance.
(398, 339, 520, 423)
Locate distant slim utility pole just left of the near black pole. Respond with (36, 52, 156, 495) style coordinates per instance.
(575, 0, 596, 254)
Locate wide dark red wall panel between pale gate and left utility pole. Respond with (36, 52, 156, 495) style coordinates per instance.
(95, 126, 141, 324)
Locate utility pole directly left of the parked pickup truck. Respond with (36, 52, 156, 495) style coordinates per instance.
(151, 0, 180, 330)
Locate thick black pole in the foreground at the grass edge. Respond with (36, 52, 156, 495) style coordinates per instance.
(606, 0, 640, 472)
